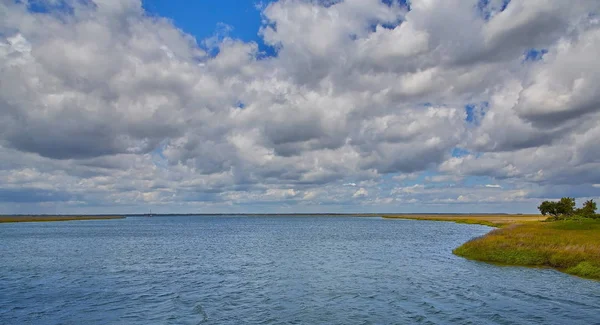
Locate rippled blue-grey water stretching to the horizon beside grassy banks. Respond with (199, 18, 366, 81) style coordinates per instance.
(0, 217, 600, 325)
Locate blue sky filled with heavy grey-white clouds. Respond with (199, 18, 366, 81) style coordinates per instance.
(0, 0, 600, 214)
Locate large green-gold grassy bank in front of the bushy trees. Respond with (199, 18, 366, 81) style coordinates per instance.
(454, 219, 600, 280)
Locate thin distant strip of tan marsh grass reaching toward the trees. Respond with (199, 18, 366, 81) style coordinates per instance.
(383, 214, 546, 227)
